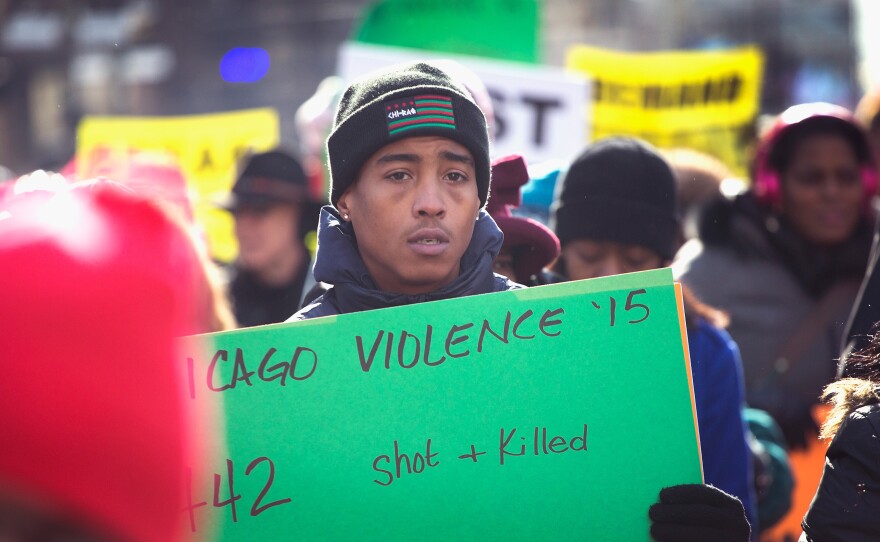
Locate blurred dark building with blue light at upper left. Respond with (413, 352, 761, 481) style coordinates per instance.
(0, 0, 367, 171)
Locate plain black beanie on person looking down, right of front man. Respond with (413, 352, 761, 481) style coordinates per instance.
(551, 137, 679, 260)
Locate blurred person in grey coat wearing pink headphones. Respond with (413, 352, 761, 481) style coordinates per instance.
(674, 103, 876, 449)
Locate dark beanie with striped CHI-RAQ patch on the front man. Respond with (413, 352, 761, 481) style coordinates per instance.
(327, 62, 490, 205)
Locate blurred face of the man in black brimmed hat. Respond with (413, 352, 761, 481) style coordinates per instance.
(234, 203, 301, 273)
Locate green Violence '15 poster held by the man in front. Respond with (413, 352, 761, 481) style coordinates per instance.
(181, 269, 702, 541)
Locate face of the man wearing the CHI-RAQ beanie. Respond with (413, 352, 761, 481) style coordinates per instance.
(337, 136, 480, 294)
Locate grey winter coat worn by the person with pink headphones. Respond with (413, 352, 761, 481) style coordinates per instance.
(673, 193, 871, 442)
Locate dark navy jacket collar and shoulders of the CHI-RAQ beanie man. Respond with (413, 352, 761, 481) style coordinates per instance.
(288, 206, 523, 322)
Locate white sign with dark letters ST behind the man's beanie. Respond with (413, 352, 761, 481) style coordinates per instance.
(337, 43, 591, 163)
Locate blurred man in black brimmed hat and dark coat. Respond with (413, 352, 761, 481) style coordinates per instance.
(220, 149, 317, 327)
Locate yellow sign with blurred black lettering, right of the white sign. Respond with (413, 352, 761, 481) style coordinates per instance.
(566, 45, 764, 175)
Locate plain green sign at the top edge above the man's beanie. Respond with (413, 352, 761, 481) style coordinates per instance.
(356, 0, 540, 63)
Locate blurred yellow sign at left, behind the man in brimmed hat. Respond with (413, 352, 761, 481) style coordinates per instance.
(76, 109, 280, 262)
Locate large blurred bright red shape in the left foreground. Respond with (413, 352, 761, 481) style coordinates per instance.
(0, 186, 210, 542)
